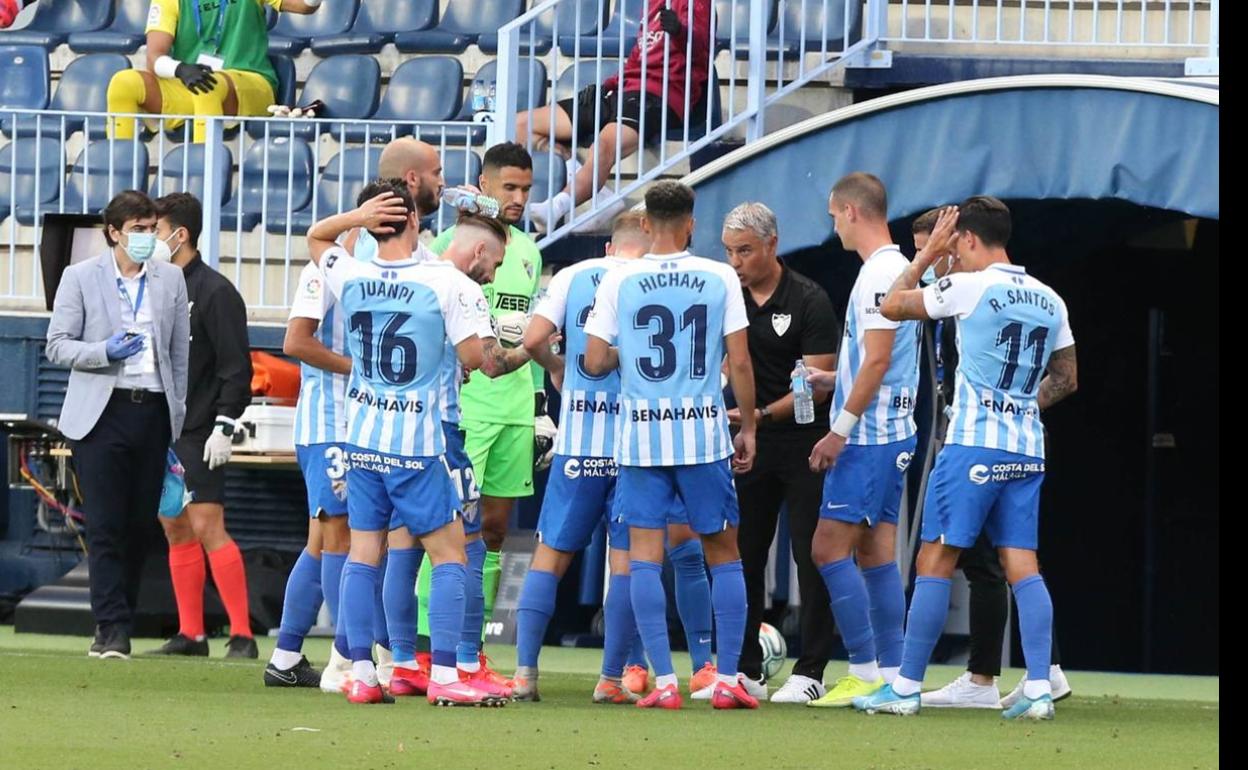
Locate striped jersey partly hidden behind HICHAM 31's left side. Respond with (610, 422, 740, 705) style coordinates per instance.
(534, 257, 629, 457)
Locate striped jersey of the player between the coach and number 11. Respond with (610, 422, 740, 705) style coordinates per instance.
(830, 245, 922, 444)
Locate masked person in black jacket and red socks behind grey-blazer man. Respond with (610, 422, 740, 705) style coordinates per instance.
(144, 192, 256, 658)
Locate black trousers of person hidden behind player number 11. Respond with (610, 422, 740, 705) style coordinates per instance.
(957, 534, 1062, 676)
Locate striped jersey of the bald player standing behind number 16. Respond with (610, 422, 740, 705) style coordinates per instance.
(290, 262, 347, 447)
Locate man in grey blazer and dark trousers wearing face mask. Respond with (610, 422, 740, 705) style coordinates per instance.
(47, 190, 190, 658)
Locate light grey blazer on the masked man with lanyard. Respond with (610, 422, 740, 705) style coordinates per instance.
(47, 252, 191, 441)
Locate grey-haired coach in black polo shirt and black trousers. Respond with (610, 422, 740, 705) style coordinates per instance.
(723, 203, 840, 703)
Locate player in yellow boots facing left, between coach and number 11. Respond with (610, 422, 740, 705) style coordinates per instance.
(806, 172, 922, 708)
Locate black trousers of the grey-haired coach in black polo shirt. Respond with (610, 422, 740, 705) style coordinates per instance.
(736, 428, 832, 681)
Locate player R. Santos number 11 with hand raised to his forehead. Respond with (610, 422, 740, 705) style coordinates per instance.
(854, 196, 1078, 719)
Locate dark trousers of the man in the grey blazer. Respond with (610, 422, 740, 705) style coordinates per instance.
(74, 391, 171, 633)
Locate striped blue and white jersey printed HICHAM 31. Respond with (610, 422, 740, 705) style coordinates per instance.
(585, 251, 749, 467)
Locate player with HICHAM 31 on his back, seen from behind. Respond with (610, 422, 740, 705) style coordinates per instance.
(585, 181, 758, 709)
